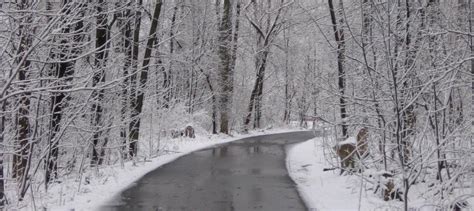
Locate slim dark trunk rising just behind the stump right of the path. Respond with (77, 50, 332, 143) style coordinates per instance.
(328, 0, 348, 138)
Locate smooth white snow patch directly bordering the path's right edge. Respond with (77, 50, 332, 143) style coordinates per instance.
(286, 138, 396, 211)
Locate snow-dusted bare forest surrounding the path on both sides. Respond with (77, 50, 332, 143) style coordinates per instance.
(0, 0, 474, 210)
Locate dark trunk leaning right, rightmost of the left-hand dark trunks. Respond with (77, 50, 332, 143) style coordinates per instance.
(130, 0, 163, 157)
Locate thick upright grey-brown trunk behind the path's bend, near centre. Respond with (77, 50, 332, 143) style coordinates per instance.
(218, 0, 233, 134)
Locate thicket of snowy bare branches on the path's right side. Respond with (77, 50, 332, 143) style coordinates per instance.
(313, 0, 474, 210)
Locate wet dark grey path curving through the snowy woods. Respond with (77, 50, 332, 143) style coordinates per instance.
(100, 131, 315, 211)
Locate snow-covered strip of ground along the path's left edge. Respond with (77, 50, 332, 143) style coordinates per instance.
(42, 129, 306, 211)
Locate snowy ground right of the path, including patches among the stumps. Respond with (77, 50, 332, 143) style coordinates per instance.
(286, 138, 474, 211)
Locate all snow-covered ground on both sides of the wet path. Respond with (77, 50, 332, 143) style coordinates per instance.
(24, 126, 470, 211)
